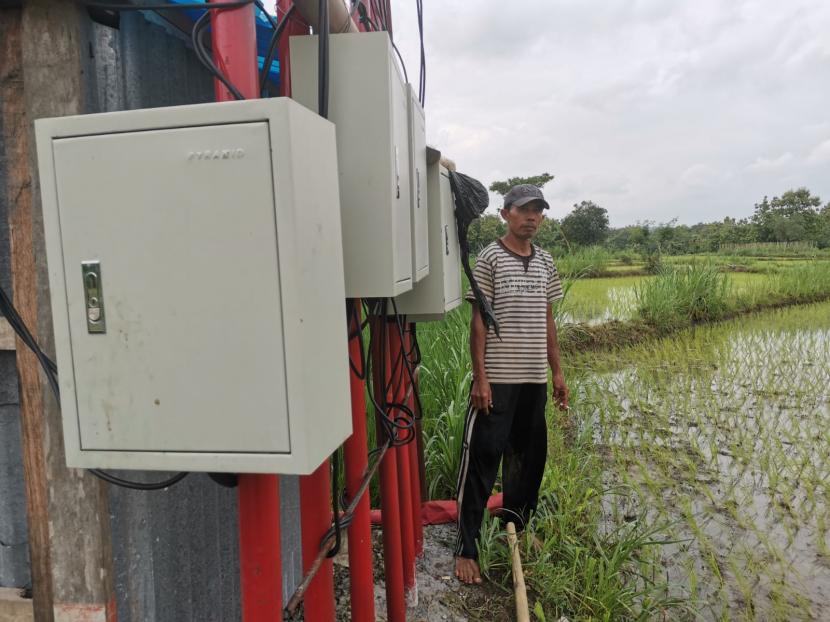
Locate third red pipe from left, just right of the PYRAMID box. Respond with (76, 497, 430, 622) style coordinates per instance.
(343, 300, 375, 622)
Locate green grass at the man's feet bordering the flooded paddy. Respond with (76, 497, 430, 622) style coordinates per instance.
(472, 379, 691, 620)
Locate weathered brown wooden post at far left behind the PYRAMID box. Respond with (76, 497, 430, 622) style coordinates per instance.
(0, 0, 115, 622)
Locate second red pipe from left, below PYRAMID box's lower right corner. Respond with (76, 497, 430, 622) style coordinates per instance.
(300, 460, 334, 622)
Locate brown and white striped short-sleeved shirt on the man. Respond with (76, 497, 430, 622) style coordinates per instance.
(465, 240, 564, 384)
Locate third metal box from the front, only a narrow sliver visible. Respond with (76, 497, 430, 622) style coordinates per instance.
(407, 84, 429, 282)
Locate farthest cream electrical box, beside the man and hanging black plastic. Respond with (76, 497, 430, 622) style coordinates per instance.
(395, 154, 461, 322)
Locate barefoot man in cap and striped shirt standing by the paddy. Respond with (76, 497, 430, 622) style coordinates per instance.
(455, 184, 568, 584)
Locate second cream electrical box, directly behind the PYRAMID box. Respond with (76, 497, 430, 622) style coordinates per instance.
(290, 32, 413, 298)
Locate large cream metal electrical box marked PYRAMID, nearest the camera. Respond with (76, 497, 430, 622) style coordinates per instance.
(36, 98, 351, 473)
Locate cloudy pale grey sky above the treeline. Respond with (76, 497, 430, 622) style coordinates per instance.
(392, 0, 830, 226)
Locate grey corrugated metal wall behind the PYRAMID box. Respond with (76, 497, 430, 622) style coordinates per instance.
(0, 13, 302, 622)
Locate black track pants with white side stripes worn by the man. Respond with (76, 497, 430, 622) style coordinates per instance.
(455, 384, 548, 559)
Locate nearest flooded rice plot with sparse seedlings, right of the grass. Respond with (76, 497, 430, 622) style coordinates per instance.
(575, 303, 830, 621)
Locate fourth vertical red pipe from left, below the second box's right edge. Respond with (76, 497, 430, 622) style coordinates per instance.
(372, 318, 406, 622)
